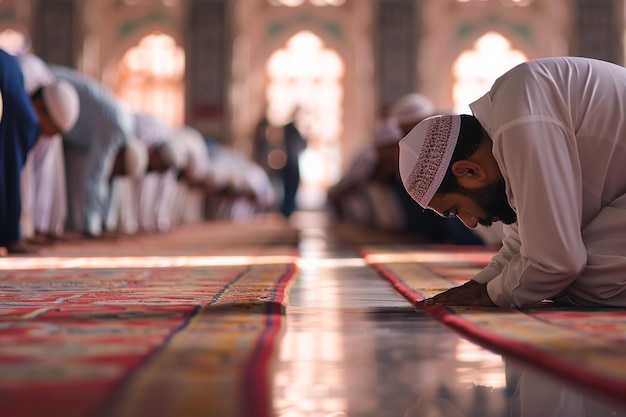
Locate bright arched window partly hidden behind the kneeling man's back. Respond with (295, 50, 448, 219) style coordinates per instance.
(452, 32, 528, 113)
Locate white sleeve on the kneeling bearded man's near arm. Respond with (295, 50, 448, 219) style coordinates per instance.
(487, 117, 587, 307)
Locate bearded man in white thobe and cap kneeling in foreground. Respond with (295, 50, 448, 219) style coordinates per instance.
(399, 57, 626, 307)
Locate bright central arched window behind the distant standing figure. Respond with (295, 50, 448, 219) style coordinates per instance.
(266, 31, 345, 205)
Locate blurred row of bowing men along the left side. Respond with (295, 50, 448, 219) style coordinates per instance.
(0, 50, 276, 253)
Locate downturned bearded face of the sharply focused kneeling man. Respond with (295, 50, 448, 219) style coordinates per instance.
(429, 180, 517, 228)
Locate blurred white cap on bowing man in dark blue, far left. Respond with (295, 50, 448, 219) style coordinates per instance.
(41, 80, 80, 133)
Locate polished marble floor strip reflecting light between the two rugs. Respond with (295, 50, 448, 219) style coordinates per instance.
(273, 213, 626, 417)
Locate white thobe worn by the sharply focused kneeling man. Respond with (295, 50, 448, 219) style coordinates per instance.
(470, 58, 626, 307)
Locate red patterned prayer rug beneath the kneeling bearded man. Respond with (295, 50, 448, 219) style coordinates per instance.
(360, 244, 626, 404)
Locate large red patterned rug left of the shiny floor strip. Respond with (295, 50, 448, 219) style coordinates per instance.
(0, 214, 297, 417)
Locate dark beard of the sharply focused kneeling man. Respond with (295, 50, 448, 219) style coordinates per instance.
(459, 180, 517, 227)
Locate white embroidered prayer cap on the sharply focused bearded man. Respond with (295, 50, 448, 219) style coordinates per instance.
(399, 115, 461, 208)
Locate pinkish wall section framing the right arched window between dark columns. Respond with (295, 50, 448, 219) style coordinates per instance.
(415, 0, 571, 108)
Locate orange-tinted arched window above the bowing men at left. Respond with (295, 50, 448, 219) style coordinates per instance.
(115, 32, 185, 127)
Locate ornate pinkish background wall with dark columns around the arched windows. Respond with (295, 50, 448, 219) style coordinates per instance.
(0, 0, 624, 172)
